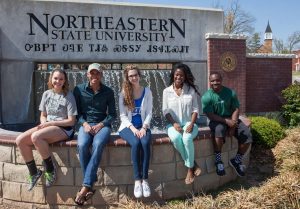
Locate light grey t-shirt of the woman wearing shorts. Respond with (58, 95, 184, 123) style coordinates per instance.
(39, 89, 77, 121)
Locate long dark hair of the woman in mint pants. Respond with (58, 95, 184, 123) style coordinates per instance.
(169, 63, 200, 95)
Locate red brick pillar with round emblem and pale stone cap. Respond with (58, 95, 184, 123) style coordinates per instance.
(206, 34, 246, 113)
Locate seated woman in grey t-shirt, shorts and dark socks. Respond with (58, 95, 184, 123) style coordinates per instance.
(16, 69, 77, 191)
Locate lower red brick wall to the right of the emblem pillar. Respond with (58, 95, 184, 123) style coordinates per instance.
(246, 57, 292, 113)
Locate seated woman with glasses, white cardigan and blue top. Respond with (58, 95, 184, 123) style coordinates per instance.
(119, 65, 152, 198)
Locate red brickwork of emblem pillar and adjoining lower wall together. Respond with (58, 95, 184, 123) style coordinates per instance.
(207, 38, 292, 113)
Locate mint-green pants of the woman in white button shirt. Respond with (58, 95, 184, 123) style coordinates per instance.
(167, 122, 198, 168)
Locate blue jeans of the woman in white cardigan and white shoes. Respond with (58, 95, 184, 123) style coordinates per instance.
(120, 128, 151, 180)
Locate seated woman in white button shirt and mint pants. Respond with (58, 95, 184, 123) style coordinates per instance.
(163, 64, 201, 184)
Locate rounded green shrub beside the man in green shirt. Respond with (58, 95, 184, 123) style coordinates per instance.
(250, 116, 285, 148)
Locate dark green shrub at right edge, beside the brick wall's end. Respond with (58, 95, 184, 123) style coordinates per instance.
(282, 84, 300, 126)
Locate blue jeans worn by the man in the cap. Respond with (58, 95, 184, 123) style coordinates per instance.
(77, 123, 111, 188)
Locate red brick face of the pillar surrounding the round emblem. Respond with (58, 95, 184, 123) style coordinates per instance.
(207, 38, 246, 113)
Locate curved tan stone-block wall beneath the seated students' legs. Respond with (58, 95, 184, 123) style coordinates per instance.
(0, 127, 249, 208)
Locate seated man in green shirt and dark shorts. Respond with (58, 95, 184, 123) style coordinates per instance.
(201, 73, 252, 176)
